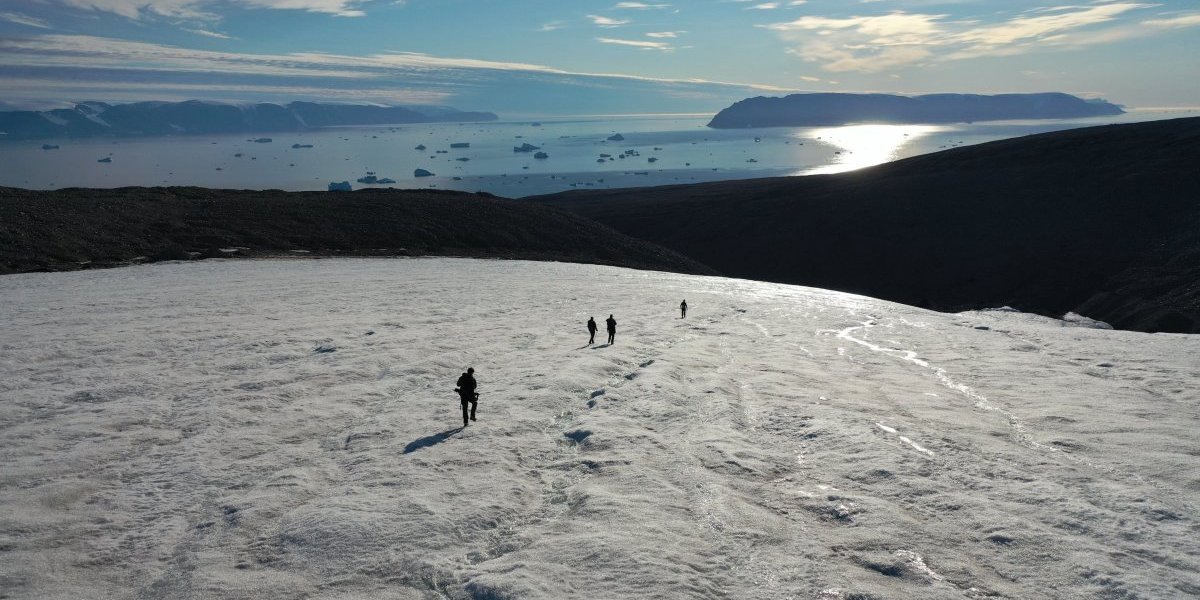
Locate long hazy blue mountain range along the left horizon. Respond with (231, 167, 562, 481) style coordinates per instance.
(0, 100, 497, 139)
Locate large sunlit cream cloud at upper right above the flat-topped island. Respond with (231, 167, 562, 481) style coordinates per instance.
(764, 2, 1166, 72)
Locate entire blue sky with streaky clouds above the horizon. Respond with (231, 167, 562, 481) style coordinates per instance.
(0, 0, 1200, 115)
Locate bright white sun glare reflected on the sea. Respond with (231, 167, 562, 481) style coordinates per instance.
(800, 125, 947, 175)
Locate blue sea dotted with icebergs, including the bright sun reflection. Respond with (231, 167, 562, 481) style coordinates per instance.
(0, 110, 1200, 198)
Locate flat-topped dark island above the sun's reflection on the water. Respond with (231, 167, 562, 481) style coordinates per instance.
(708, 92, 1124, 128)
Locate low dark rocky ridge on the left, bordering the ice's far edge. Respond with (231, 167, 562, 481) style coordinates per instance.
(0, 187, 714, 274)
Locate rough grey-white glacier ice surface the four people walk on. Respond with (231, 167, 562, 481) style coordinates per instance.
(0, 259, 1200, 600)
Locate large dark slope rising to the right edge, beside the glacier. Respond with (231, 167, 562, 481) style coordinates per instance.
(533, 118, 1200, 332)
